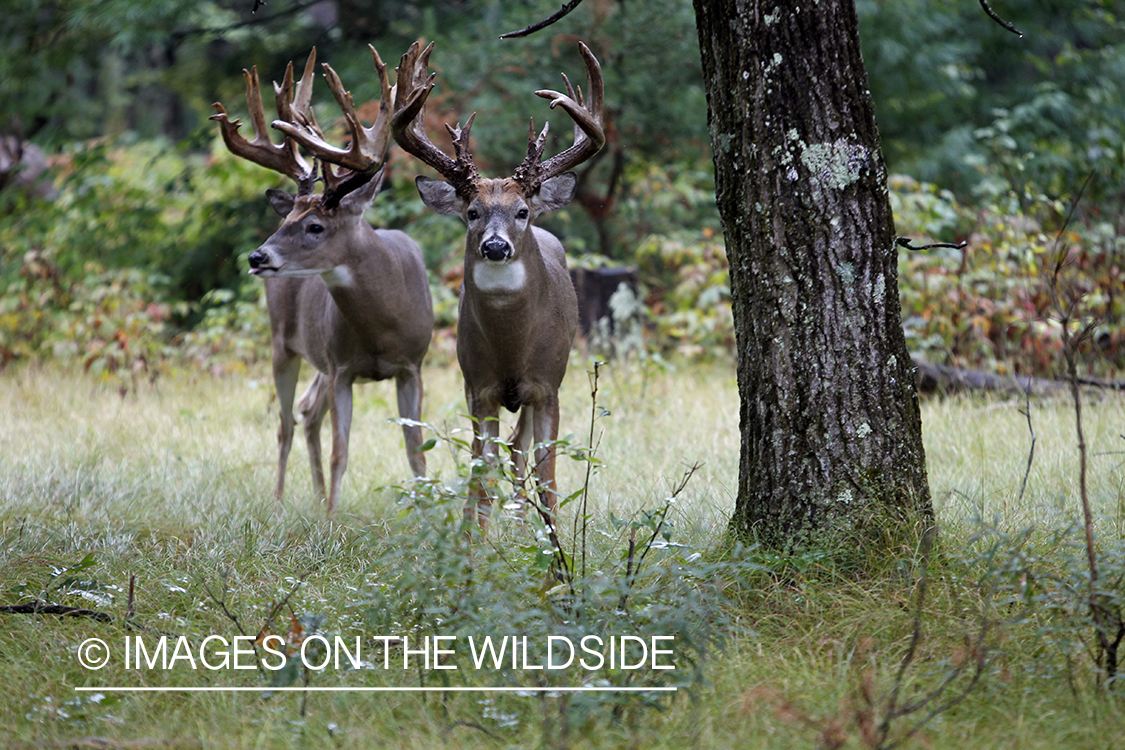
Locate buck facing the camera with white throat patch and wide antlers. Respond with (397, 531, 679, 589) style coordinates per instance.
(390, 44, 605, 532)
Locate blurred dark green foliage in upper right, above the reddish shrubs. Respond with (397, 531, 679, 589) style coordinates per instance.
(856, 0, 1125, 208)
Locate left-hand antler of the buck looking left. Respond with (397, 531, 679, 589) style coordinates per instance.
(210, 47, 316, 191)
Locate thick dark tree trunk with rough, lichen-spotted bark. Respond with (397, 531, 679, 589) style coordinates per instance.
(694, 0, 933, 551)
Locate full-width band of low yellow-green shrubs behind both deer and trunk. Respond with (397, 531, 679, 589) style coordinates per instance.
(0, 142, 1125, 387)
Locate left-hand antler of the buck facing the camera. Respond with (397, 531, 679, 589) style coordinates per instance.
(390, 42, 480, 200)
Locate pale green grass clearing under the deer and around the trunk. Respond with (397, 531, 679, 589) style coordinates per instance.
(0, 359, 1125, 750)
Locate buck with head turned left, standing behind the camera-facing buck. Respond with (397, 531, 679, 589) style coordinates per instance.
(212, 47, 433, 514)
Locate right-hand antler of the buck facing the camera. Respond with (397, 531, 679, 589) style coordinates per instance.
(515, 42, 605, 193)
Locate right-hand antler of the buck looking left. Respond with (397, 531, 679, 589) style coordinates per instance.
(273, 45, 395, 209)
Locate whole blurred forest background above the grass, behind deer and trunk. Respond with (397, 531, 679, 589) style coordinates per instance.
(0, 0, 1125, 386)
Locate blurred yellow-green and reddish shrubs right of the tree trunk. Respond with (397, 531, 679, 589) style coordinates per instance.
(891, 177, 1125, 377)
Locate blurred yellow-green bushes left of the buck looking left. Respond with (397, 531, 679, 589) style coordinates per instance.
(0, 142, 276, 388)
